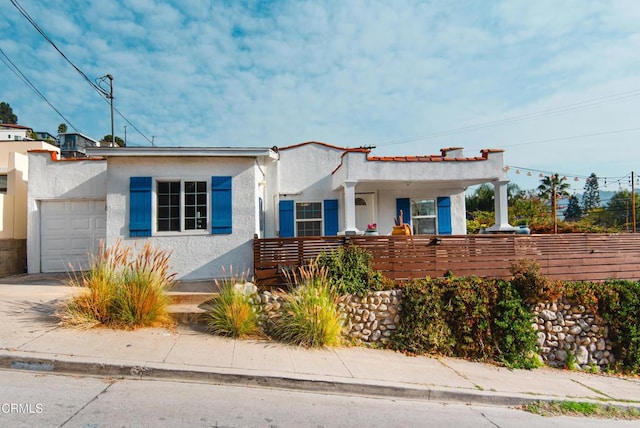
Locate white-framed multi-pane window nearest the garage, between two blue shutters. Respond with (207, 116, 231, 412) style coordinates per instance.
(156, 180, 208, 232)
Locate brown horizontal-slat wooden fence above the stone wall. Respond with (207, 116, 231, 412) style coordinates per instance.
(254, 233, 640, 287)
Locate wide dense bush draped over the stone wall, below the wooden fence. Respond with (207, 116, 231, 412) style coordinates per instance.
(392, 277, 536, 368)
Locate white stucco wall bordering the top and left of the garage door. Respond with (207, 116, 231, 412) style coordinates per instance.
(27, 152, 107, 273)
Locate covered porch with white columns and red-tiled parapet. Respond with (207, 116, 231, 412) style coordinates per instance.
(332, 148, 515, 235)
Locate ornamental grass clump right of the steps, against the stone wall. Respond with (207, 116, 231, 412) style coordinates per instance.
(271, 263, 343, 347)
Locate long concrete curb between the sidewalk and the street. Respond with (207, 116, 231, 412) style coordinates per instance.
(0, 352, 640, 410)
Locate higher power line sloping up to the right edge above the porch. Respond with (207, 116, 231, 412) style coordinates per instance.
(377, 88, 640, 146)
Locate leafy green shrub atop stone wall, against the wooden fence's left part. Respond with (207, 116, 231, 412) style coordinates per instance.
(316, 245, 386, 295)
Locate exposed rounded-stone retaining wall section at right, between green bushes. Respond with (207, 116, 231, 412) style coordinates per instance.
(533, 299, 614, 369)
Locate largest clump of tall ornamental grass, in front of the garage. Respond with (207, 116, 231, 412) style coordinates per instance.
(58, 241, 175, 327)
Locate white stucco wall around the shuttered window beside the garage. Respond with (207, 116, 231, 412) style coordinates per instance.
(107, 157, 264, 280)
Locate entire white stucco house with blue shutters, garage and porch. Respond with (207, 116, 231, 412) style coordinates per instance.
(27, 142, 512, 280)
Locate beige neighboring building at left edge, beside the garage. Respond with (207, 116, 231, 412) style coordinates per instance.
(0, 138, 58, 277)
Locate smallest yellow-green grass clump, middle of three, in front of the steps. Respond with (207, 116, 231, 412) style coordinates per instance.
(206, 276, 261, 337)
